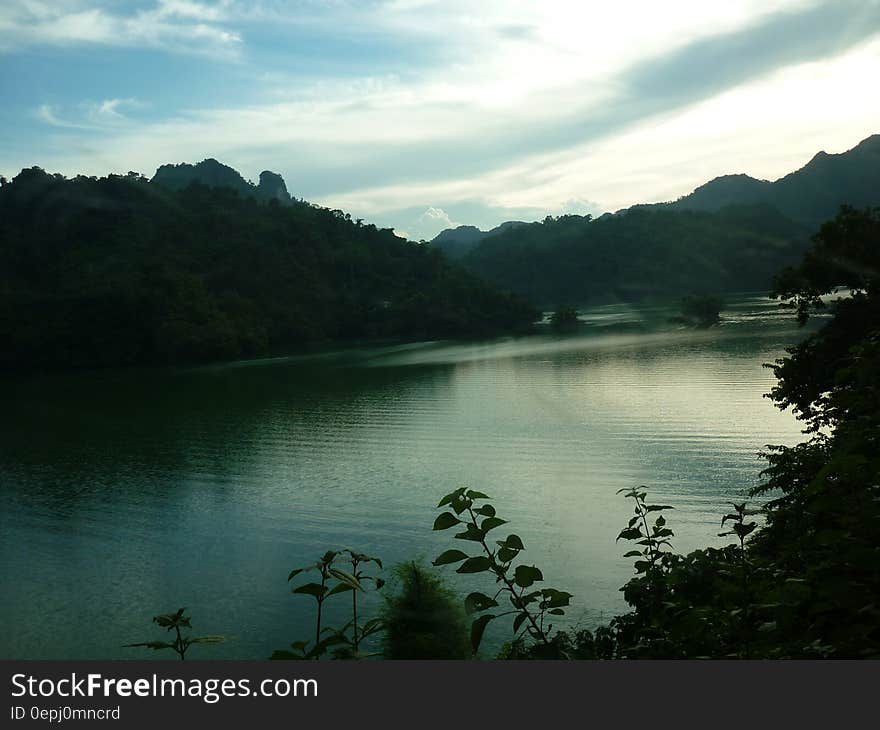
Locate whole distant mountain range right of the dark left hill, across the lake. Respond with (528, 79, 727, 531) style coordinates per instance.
(431, 135, 880, 307)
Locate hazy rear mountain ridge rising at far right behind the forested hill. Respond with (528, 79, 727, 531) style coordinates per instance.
(661, 134, 880, 228)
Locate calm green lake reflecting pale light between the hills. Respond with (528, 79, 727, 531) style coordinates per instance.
(0, 296, 803, 659)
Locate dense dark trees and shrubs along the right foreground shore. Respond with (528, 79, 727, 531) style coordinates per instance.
(610, 207, 880, 658)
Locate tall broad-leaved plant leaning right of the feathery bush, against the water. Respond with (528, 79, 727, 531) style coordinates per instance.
(434, 487, 572, 653)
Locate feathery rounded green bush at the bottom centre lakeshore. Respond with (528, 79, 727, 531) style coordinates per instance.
(382, 562, 471, 659)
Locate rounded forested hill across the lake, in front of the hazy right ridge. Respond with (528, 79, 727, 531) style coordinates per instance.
(461, 205, 811, 306)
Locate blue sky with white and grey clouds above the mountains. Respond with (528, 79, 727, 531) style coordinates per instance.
(0, 0, 880, 240)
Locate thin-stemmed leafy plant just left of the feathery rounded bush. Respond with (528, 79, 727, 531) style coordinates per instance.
(270, 549, 385, 659)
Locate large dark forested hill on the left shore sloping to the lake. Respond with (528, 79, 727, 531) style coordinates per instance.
(0, 163, 535, 369)
